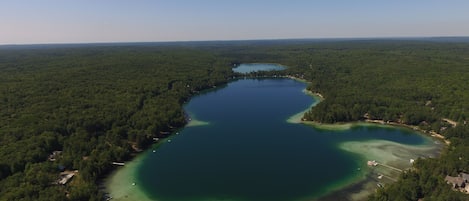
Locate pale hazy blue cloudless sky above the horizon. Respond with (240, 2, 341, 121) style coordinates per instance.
(0, 0, 469, 44)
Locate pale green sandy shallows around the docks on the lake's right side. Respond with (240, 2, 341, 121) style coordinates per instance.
(330, 140, 441, 201)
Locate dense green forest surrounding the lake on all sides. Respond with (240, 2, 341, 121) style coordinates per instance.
(0, 40, 469, 200)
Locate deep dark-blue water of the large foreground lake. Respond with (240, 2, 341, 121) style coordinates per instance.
(136, 78, 433, 201)
